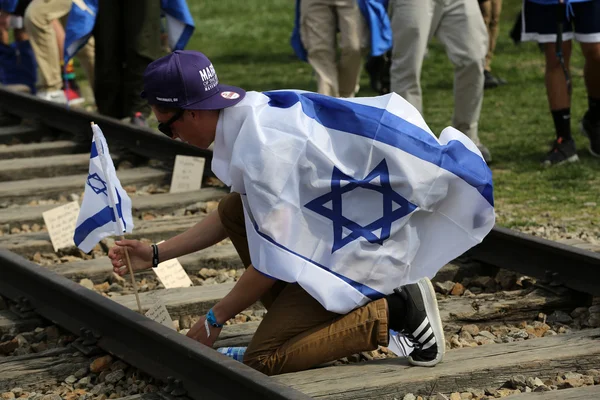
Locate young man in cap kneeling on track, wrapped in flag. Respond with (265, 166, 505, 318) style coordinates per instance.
(109, 51, 494, 375)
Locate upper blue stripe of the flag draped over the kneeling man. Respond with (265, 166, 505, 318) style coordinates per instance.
(263, 91, 494, 207)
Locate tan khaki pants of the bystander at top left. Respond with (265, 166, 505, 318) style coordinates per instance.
(24, 0, 94, 91)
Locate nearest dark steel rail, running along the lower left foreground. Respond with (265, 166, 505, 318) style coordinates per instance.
(0, 250, 310, 400)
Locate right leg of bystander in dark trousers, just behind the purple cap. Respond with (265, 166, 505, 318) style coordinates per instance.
(120, 0, 162, 117)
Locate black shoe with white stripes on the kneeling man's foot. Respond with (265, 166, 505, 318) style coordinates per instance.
(388, 278, 446, 367)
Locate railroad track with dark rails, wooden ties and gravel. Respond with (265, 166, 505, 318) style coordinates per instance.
(0, 89, 600, 400)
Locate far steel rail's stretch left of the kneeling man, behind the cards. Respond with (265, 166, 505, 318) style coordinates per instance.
(0, 87, 212, 174)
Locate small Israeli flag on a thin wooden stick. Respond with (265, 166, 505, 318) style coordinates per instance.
(73, 124, 133, 253)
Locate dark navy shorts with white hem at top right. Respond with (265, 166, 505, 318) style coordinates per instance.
(521, 0, 600, 43)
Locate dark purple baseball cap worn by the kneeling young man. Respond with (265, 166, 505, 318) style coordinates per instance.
(141, 50, 246, 110)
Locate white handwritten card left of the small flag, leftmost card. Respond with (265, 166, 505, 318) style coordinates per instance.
(42, 201, 79, 251)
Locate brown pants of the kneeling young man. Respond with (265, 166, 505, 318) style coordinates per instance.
(219, 193, 388, 375)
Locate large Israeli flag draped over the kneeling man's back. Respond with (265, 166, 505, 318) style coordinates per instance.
(212, 91, 495, 313)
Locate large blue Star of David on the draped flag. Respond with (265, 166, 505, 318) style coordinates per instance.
(305, 159, 417, 253)
